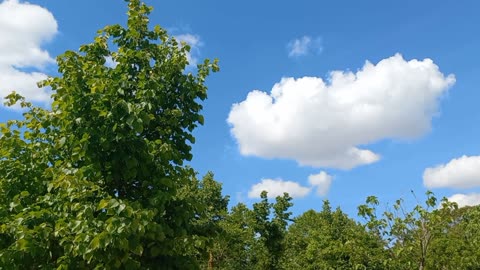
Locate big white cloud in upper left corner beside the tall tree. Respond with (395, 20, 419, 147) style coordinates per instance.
(0, 0, 57, 105)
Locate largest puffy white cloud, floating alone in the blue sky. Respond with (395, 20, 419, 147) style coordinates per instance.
(227, 54, 455, 169)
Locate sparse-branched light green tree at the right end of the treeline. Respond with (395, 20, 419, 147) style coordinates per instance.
(359, 192, 480, 270)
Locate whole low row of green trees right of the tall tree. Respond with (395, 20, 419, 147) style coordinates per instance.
(204, 192, 480, 270)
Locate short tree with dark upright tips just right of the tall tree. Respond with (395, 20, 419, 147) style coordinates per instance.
(213, 191, 292, 269)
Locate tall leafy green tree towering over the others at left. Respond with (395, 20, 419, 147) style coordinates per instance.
(0, 0, 218, 269)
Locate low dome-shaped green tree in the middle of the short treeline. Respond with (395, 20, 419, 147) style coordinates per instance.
(282, 201, 385, 270)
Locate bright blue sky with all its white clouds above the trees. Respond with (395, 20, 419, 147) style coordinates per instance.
(0, 0, 480, 215)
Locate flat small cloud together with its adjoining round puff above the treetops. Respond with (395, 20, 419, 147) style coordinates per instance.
(248, 171, 332, 198)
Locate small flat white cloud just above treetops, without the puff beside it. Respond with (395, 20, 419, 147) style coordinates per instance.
(248, 179, 310, 198)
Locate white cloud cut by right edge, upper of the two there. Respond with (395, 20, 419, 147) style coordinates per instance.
(423, 156, 480, 188)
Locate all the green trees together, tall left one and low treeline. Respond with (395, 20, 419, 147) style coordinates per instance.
(0, 0, 480, 270)
